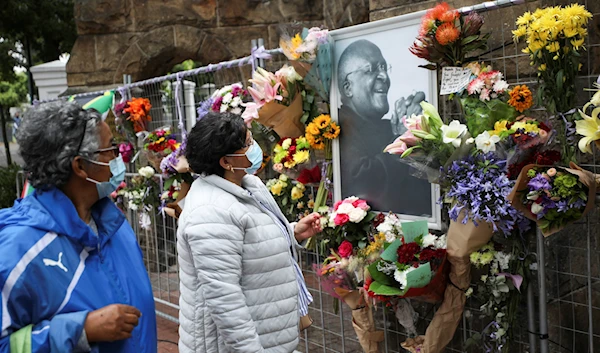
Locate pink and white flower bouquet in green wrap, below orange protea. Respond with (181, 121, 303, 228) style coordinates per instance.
(460, 63, 520, 136)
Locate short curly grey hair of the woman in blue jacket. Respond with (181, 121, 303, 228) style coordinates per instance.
(17, 102, 101, 190)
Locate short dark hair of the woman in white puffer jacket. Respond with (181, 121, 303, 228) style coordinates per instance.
(185, 112, 248, 176)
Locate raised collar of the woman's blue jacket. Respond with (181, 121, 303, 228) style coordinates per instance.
(32, 188, 125, 248)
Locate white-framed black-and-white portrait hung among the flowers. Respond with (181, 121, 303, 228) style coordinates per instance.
(330, 11, 442, 229)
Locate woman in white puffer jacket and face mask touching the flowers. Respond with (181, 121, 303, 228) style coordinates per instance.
(177, 113, 320, 353)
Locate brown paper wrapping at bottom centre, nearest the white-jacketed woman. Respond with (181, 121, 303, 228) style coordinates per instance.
(334, 288, 384, 353)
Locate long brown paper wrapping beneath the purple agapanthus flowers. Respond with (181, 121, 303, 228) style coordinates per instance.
(402, 211, 494, 353)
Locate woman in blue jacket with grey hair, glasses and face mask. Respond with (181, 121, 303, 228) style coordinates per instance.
(0, 103, 157, 353)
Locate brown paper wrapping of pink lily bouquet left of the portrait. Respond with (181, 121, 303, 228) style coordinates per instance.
(257, 94, 305, 137)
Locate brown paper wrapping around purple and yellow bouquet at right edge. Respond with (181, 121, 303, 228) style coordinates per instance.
(508, 163, 600, 237)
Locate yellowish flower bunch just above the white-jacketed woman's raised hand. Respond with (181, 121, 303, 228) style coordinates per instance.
(266, 174, 314, 222)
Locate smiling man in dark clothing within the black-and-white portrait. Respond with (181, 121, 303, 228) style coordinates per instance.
(335, 39, 433, 217)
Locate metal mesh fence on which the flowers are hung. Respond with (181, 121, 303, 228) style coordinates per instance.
(25, 0, 600, 353)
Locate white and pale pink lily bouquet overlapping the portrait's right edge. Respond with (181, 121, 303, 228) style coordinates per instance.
(384, 102, 472, 183)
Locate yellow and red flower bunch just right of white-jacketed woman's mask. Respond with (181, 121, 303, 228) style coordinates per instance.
(273, 137, 310, 179)
